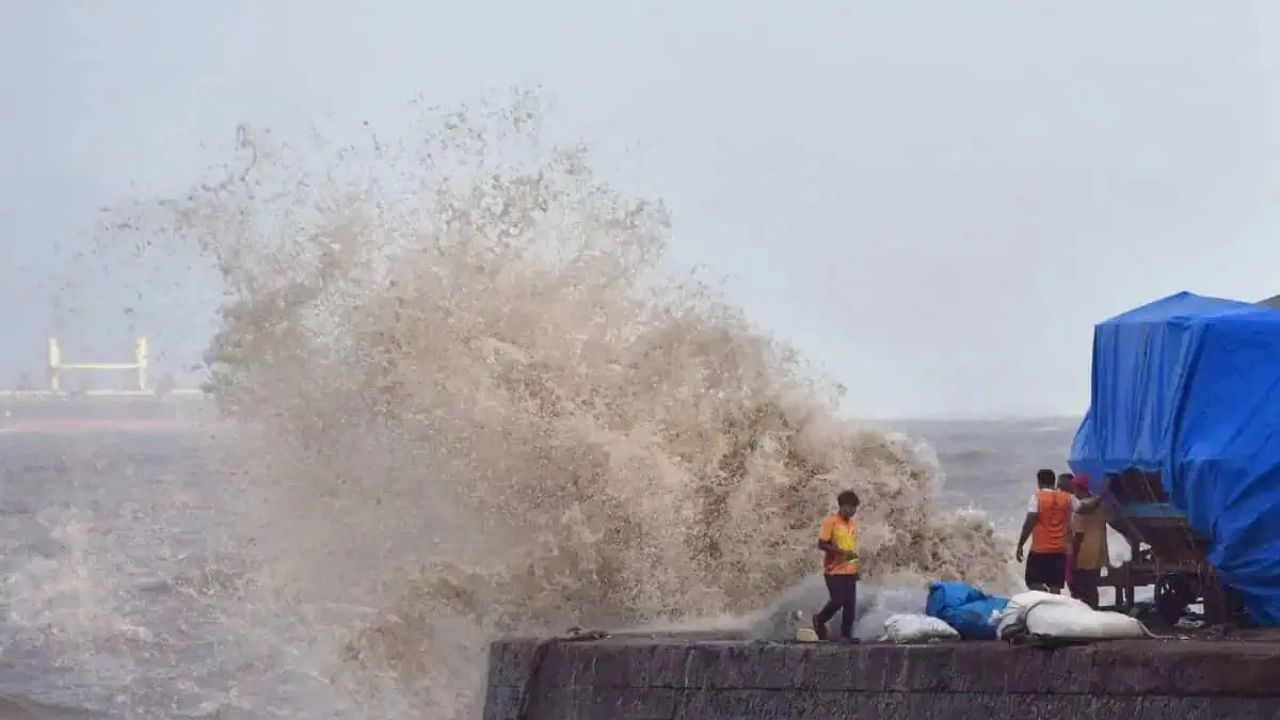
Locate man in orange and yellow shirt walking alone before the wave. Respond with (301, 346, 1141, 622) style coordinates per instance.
(813, 489, 860, 642)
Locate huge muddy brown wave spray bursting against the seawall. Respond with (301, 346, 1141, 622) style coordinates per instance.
(74, 96, 1010, 720)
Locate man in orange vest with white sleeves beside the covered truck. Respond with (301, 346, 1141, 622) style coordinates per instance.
(1018, 470, 1098, 593)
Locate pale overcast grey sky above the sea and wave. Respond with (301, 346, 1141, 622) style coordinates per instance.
(0, 0, 1280, 416)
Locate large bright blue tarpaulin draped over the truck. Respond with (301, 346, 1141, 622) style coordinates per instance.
(1070, 293, 1280, 625)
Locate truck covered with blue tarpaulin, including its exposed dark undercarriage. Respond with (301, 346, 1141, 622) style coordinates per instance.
(1070, 293, 1280, 625)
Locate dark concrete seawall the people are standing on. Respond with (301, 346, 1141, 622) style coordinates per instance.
(484, 638, 1280, 720)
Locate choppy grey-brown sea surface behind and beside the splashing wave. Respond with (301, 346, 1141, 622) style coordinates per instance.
(0, 419, 1075, 719)
